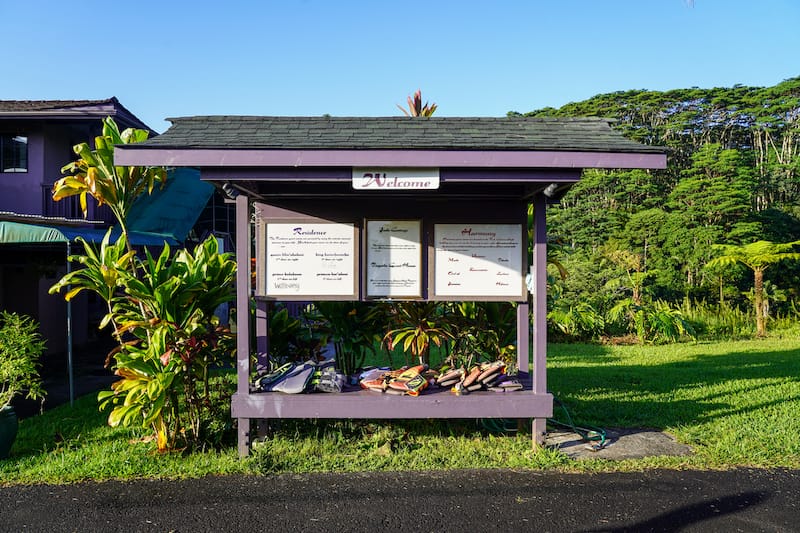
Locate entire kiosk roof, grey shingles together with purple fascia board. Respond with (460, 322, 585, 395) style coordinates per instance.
(116, 116, 666, 168)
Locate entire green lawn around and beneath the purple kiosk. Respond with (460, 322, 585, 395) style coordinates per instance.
(0, 334, 800, 484)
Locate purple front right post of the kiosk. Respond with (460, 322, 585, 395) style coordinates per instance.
(533, 194, 547, 446)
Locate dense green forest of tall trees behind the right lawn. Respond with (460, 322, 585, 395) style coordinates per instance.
(526, 77, 800, 334)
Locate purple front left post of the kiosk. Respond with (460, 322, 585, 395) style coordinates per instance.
(232, 194, 250, 456)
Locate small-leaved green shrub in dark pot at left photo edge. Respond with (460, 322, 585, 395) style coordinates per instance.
(0, 311, 45, 459)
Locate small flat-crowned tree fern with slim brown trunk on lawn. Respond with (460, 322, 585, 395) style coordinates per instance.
(706, 241, 800, 337)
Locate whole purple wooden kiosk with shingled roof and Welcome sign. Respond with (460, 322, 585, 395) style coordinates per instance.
(116, 116, 666, 455)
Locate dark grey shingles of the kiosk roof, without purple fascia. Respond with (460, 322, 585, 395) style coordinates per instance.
(130, 116, 664, 153)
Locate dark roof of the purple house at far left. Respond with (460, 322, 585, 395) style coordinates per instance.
(0, 97, 152, 131)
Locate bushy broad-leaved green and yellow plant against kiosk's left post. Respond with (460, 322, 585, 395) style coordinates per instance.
(50, 230, 236, 451)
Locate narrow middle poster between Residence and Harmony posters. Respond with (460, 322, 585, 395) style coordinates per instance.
(365, 220, 422, 298)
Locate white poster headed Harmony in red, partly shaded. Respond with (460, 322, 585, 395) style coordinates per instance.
(434, 224, 525, 299)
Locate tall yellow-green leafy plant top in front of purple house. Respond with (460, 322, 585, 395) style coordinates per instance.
(53, 117, 167, 250)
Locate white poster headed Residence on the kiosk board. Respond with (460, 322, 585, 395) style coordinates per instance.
(264, 221, 358, 298)
